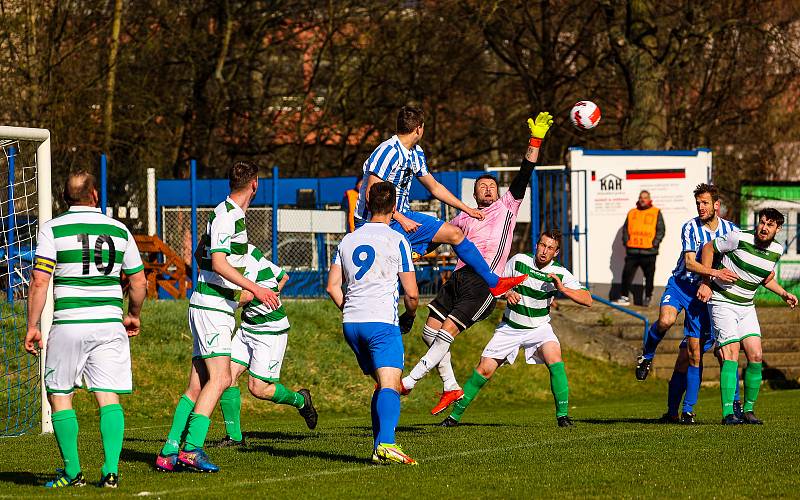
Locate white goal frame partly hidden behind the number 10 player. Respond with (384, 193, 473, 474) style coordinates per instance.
(0, 126, 53, 433)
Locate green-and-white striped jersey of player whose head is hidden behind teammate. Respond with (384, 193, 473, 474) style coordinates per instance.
(241, 245, 289, 335)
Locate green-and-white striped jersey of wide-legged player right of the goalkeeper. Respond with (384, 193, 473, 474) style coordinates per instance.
(503, 253, 583, 328)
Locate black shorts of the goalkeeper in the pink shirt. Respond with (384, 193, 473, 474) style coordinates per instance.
(428, 267, 497, 332)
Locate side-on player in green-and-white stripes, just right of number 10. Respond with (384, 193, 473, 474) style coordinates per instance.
(156, 161, 278, 472)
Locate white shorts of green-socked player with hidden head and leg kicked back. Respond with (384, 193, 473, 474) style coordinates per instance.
(231, 328, 289, 382)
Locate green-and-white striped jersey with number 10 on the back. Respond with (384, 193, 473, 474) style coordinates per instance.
(34, 206, 144, 325)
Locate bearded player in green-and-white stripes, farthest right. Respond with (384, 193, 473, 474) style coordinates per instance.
(697, 208, 797, 425)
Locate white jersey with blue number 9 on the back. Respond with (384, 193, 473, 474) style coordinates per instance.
(333, 222, 414, 325)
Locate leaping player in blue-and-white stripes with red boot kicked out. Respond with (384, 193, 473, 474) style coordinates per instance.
(354, 106, 524, 297)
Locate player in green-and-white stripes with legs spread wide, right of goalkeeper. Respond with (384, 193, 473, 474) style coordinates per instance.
(441, 230, 592, 427)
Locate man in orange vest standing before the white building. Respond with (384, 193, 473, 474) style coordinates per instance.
(615, 191, 664, 307)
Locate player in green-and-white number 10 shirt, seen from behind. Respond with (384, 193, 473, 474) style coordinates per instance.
(25, 171, 147, 488)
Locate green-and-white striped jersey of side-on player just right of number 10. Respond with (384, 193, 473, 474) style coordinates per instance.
(189, 198, 247, 316)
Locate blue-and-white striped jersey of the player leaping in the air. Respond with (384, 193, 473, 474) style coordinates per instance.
(355, 135, 429, 220)
